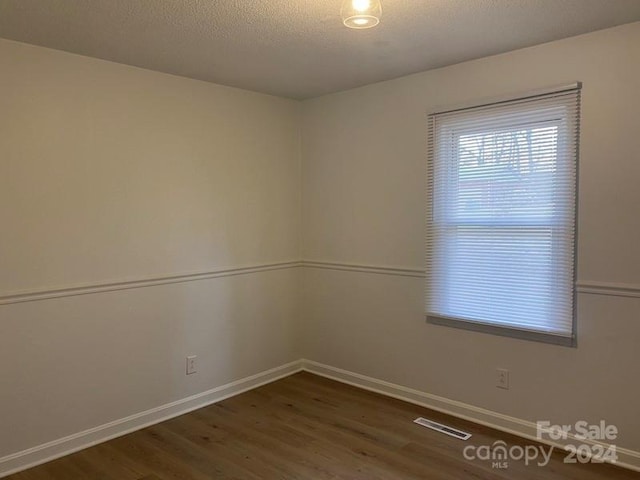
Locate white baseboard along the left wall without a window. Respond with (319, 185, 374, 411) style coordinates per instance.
(0, 360, 302, 478)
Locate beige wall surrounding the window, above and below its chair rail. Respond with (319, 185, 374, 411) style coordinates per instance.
(302, 23, 640, 451)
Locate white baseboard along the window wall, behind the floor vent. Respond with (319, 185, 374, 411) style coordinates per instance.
(301, 360, 640, 472)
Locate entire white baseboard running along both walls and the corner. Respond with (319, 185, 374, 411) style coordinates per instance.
(0, 360, 640, 478)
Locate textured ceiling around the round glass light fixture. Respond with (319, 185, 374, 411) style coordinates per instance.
(0, 0, 640, 98)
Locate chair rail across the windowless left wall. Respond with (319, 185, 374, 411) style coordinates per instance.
(0, 261, 300, 305)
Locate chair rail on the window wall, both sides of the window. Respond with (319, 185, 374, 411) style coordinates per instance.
(301, 260, 640, 297)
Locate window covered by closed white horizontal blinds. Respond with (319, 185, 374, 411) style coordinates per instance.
(427, 84, 580, 345)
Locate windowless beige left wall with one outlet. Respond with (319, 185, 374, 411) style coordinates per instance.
(0, 40, 300, 457)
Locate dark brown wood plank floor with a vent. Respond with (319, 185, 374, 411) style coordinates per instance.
(7, 373, 640, 480)
